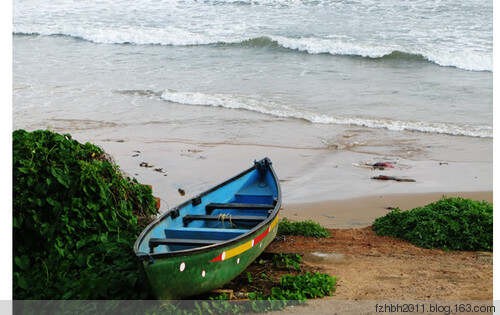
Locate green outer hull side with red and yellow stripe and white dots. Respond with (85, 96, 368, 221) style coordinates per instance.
(143, 216, 278, 300)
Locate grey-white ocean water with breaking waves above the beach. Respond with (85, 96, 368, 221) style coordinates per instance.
(13, 0, 492, 147)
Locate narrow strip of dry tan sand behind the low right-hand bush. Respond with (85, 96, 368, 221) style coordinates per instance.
(281, 191, 493, 229)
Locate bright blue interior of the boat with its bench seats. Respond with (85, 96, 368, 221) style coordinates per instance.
(138, 162, 278, 254)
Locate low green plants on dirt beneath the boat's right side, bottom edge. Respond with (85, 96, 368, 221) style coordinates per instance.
(187, 253, 337, 314)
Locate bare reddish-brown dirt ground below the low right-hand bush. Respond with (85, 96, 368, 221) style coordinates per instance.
(266, 227, 493, 301)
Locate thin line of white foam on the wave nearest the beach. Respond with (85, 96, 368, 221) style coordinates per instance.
(161, 89, 493, 138)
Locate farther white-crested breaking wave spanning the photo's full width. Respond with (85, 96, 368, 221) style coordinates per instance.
(14, 31, 493, 71)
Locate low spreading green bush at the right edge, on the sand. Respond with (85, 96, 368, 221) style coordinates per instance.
(373, 197, 493, 251)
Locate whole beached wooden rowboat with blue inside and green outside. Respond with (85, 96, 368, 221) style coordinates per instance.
(134, 158, 281, 299)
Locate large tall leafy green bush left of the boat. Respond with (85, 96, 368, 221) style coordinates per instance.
(13, 130, 156, 300)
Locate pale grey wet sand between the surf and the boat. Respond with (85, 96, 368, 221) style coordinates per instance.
(69, 126, 493, 217)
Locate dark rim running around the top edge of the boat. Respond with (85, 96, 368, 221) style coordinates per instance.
(134, 157, 281, 260)
